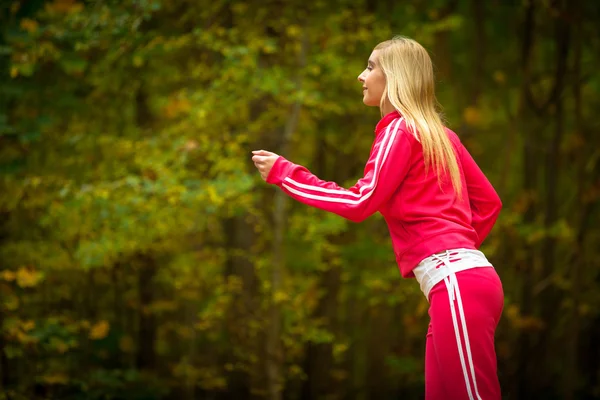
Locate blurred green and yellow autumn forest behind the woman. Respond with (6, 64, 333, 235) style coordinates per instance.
(0, 0, 600, 400)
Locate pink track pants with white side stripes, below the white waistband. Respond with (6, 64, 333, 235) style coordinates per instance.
(425, 267, 504, 400)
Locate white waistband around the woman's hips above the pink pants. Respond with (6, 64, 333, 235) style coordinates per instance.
(413, 249, 493, 300)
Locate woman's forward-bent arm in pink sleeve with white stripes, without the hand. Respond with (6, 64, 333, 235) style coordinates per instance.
(267, 119, 411, 222)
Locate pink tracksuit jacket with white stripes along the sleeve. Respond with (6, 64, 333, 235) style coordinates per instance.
(267, 111, 502, 278)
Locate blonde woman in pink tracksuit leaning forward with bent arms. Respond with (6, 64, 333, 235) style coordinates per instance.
(252, 37, 504, 400)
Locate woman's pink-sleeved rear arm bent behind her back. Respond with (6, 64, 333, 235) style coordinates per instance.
(460, 144, 502, 247)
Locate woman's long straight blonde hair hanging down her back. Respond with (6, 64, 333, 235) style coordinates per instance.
(375, 36, 462, 198)
